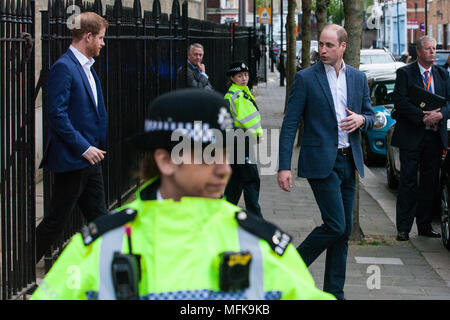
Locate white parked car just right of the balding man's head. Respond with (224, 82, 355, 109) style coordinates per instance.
(359, 48, 406, 78)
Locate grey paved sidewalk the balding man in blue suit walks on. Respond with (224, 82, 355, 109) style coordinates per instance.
(32, 67, 450, 300)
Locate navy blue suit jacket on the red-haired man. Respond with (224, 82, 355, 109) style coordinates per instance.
(41, 49, 107, 172)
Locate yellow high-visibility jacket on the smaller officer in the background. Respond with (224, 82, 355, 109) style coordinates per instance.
(225, 83, 263, 138)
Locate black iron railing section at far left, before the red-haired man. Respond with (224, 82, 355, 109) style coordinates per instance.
(0, 0, 36, 300)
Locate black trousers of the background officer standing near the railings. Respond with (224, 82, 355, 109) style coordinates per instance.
(225, 163, 262, 217)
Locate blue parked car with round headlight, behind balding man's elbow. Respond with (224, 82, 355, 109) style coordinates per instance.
(361, 73, 396, 165)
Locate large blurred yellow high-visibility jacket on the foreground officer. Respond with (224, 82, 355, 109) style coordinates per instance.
(31, 180, 334, 300)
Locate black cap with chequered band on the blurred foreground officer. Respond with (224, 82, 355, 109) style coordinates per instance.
(130, 89, 234, 150)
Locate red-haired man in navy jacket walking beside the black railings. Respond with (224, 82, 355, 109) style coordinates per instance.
(36, 12, 108, 262)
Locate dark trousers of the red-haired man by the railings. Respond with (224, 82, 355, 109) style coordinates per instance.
(36, 163, 107, 262)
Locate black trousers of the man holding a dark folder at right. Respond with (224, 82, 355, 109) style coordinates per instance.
(396, 130, 443, 233)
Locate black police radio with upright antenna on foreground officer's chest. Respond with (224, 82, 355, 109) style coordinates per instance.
(111, 226, 141, 300)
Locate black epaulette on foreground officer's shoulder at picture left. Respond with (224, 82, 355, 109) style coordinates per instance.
(80, 208, 137, 246)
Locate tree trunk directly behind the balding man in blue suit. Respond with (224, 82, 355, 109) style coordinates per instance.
(343, 0, 364, 241)
